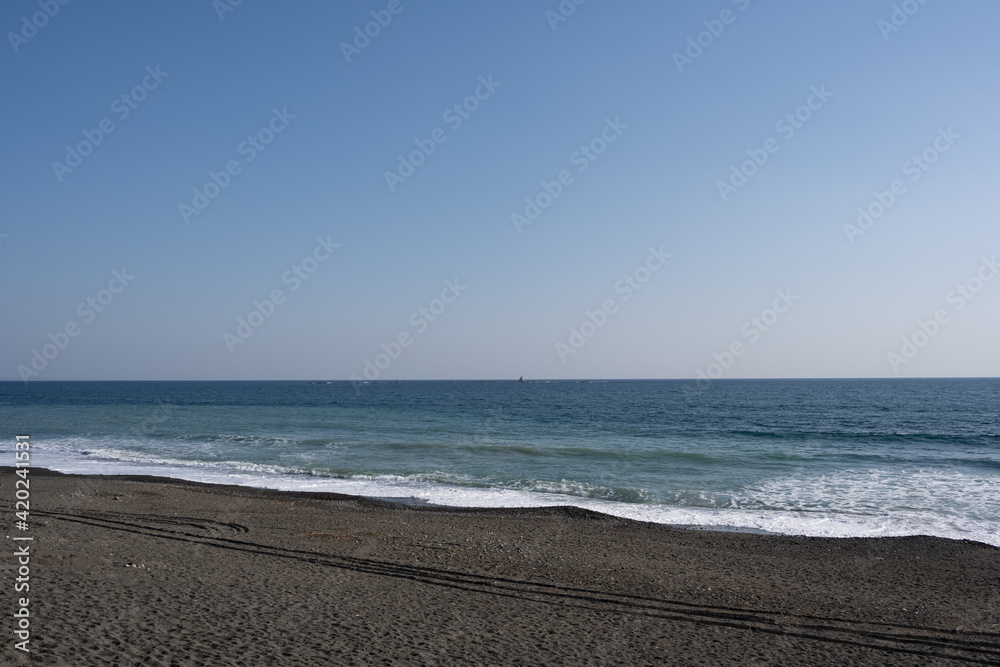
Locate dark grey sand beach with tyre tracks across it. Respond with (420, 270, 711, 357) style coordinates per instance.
(7, 468, 1000, 666)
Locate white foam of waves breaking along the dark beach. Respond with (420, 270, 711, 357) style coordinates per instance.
(21, 439, 1000, 547)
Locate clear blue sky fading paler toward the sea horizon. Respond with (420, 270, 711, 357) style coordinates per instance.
(0, 0, 1000, 380)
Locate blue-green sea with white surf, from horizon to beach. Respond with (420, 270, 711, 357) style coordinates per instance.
(0, 379, 1000, 546)
